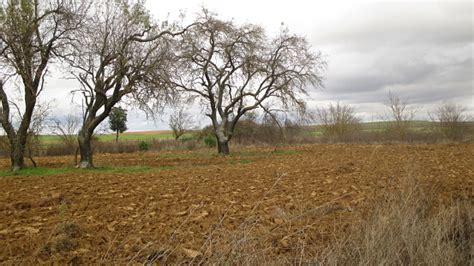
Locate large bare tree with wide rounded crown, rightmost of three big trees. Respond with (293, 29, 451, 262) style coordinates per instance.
(163, 10, 325, 155)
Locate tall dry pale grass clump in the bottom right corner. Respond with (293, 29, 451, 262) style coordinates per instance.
(315, 177, 474, 265)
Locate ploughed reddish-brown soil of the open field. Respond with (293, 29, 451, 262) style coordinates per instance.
(0, 145, 474, 264)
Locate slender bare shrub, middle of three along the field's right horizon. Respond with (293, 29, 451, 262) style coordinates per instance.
(386, 91, 417, 140)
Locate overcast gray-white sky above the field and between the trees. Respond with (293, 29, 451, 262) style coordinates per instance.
(42, 0, 474, 131)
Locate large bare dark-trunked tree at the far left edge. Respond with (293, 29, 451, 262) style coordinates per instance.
(0, 0, 86, 171)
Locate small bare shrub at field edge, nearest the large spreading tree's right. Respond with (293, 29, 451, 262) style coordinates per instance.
(315, 102, 360, 141)
